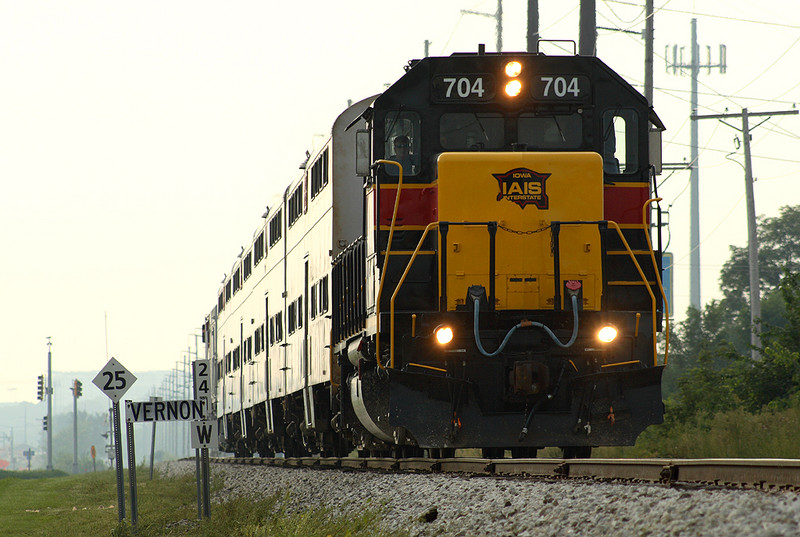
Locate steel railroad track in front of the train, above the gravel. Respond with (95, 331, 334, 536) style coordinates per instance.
(211, 457, 800, 489)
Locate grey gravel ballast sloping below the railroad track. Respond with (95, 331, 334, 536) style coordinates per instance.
(161, 461, 800, 537)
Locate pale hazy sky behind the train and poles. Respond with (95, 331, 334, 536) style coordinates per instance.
(0, 0, 800, 401)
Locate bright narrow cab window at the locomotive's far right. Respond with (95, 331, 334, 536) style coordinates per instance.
(602, 108, 639, 174)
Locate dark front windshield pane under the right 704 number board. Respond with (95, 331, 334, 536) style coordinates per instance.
(517, 114, 583, 150)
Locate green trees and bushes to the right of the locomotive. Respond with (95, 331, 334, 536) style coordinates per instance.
(663, 206, 800, 426)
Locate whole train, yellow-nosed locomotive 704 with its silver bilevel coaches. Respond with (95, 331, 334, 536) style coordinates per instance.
(203, 46, 668, 457)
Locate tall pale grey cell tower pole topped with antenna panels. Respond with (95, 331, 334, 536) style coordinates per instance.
(664, 19, 727, 310)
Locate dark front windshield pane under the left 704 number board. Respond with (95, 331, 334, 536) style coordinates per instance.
(439, 113, 505, 151)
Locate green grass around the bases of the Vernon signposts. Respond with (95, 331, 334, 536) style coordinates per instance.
(0, 469, 404, 537)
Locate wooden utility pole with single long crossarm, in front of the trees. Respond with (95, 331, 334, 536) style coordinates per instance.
(692, 108, 798, 360)
